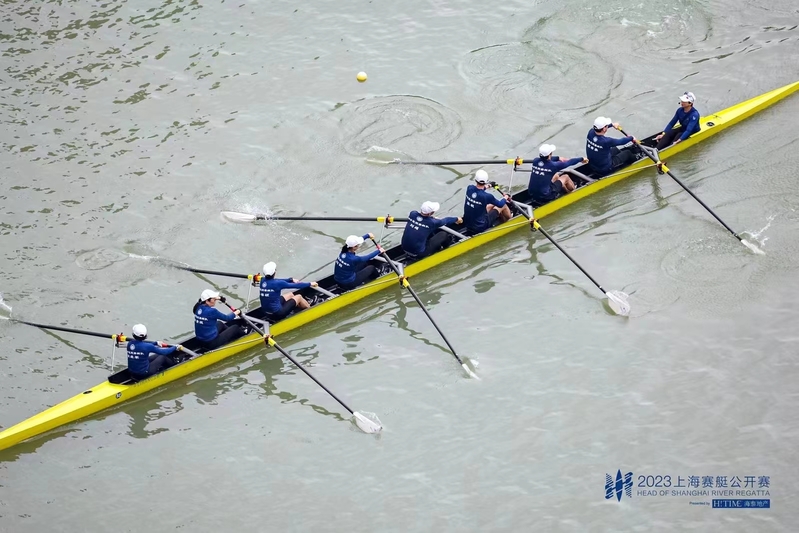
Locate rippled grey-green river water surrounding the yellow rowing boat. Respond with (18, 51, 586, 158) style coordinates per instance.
(0, 0, 799, 532)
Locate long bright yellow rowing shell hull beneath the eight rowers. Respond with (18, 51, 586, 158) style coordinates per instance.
(0, 82, 799, 450)
